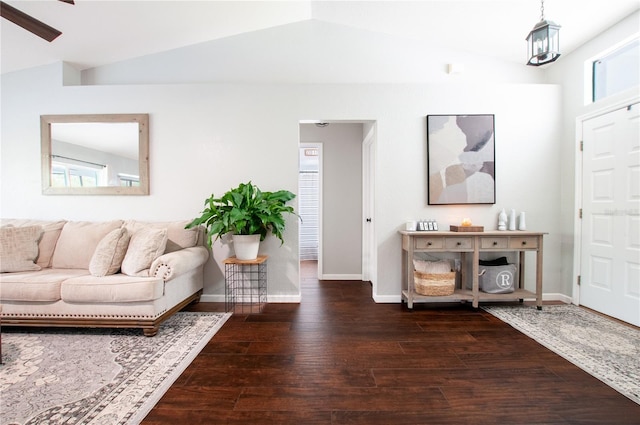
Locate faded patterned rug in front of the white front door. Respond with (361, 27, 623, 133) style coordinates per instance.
(483, 304, 640, 404)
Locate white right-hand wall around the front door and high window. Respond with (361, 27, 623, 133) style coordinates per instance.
(547, 11, 640, 296)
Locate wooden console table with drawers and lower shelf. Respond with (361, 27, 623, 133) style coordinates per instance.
(400, 230, 546, 310)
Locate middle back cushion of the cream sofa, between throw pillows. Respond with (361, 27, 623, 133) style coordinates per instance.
(51, 220, 122, 270)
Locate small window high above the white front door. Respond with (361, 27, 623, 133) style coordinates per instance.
(592, 39, 640, 102)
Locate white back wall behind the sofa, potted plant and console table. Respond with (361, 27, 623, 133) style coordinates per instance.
(0, 65, 565, 301)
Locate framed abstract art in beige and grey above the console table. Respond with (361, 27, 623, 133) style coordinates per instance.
(427, 115, 496, 205)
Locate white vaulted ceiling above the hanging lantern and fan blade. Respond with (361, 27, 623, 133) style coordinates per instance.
(0, 0, 640, 73)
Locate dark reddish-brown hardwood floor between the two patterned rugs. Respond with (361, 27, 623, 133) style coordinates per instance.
(143, 260, 640, 425)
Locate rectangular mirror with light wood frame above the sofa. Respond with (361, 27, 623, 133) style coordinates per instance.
(40, 114, 149, 195)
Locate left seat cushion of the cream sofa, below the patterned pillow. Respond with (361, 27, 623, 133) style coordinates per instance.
(0, 269, 87, 302)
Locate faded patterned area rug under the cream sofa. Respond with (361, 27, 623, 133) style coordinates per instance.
(0, 312, 231, 425)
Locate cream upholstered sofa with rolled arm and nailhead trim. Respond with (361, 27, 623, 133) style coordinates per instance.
(0, 219, 209, 336)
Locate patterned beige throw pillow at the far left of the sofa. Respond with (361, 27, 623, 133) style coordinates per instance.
(0, 226, 42, 273)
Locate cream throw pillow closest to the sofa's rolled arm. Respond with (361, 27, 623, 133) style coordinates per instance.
(121, 228, 167, 276)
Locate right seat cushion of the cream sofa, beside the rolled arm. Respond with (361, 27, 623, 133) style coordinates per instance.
(60, 273, 164, 303)
